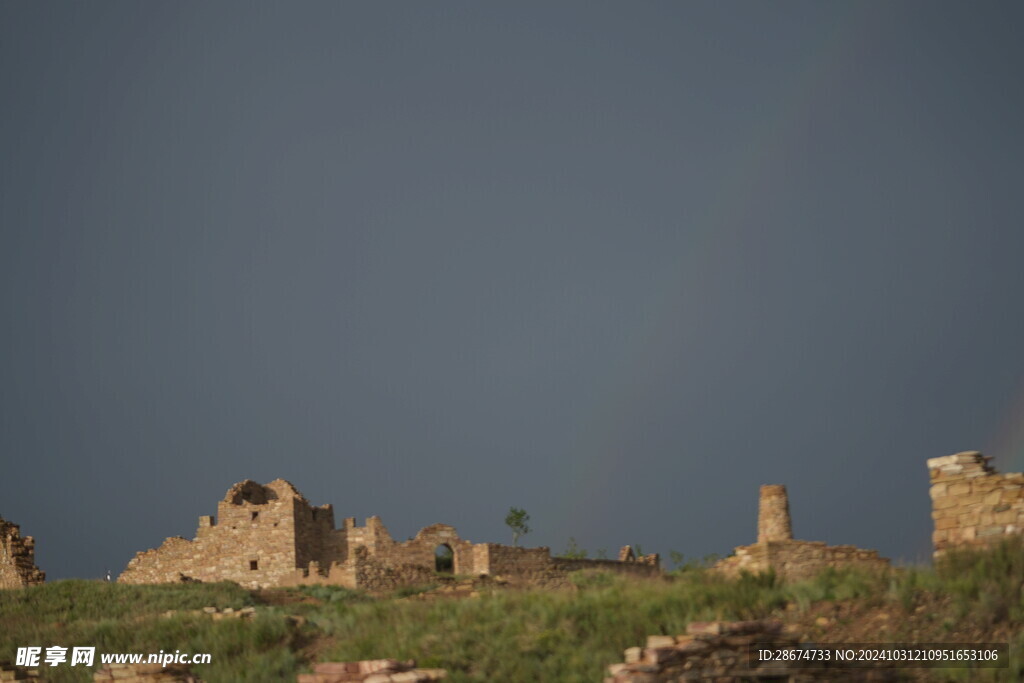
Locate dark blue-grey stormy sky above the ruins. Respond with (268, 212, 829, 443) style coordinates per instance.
(0, 0, 1024, 578)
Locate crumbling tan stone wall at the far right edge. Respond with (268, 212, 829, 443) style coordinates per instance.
(928, 451, 1024, 558)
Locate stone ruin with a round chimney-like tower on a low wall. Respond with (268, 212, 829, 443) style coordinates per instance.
(712, 484, 890, 581)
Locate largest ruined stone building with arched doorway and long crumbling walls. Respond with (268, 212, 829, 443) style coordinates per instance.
(118, 479, 660, 590)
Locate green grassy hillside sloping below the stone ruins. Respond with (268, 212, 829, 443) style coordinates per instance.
(0, 541, 1024, 683)
